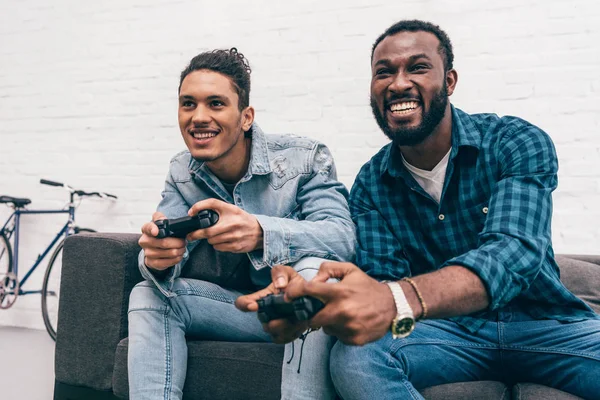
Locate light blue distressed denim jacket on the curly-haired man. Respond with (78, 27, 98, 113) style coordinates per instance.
(139, 123, 356, 297)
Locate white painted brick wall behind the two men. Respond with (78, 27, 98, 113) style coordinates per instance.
(0, 0, 600, 328)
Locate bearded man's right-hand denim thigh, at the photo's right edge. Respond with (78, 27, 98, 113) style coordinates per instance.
(500, 320, 600, 399)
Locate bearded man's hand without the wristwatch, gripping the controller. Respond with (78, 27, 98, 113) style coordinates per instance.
(235, 265, 308, 344)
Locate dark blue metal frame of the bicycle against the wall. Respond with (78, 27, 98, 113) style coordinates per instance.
(0, 202, 75, 295)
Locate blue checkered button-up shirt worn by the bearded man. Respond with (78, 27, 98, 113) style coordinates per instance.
(350, 107, 596, 332)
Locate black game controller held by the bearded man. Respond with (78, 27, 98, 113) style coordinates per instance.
(256, 294, 325, 323)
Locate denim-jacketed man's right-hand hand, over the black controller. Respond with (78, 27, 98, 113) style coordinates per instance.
(187, 199, 263, 253)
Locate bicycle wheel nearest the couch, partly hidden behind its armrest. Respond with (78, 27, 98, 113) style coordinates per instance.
(42, 228, 96, 341)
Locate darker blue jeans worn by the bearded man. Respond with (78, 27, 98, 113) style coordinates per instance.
(330, 311, 600, 400)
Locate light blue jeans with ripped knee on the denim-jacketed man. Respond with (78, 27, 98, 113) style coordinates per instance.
(127, 257, 335, 400)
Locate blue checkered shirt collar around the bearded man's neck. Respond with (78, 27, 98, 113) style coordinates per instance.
(380, 105, 481, 178)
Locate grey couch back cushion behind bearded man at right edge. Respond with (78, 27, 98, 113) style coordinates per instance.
(556, 255, 600, 313)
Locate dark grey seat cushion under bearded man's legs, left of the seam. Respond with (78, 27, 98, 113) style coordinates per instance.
(419, 381, 510, 400)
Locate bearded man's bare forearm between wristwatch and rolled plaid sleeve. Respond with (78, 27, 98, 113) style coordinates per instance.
(400, 265, 489, 319)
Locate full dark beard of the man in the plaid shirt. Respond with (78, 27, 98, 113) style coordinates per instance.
(371, 82, 448, 146)
